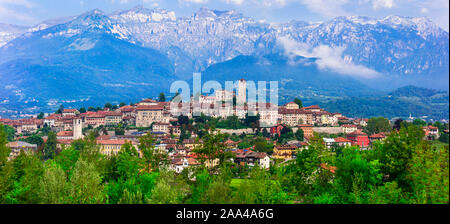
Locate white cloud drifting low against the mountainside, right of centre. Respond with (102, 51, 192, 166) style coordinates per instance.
(278, 37, 380, 78)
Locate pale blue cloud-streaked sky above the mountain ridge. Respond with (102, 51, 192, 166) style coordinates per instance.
(0, 0, 449, 31)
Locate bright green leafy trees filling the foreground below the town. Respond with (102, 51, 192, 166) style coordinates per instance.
(0, 122, 449, 204)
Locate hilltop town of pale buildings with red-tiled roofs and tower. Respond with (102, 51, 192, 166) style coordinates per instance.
(0, 85, 448, 173)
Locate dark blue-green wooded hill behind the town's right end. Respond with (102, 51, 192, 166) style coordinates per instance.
(294, 86, 449, 120)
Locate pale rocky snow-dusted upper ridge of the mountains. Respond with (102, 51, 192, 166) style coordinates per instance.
(0, 6, 449, 78)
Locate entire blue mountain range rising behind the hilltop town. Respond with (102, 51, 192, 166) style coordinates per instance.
(0, 7, 449, 117)
